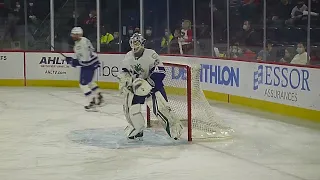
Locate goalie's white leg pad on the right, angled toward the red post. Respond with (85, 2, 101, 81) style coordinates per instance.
(147, 89, 183, 139)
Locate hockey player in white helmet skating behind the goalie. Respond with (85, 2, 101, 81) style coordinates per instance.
(66, 27, 104, 111)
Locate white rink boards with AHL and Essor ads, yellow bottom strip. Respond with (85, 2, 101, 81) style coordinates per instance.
(0, 52, 320, 122)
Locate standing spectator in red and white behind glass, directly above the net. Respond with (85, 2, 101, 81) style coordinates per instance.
(179, 20, 193, 54)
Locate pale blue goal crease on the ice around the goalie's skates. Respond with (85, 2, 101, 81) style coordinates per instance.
(68, 128, 187, 149)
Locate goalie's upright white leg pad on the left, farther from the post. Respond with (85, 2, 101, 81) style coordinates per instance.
(123, 92, 145, 137)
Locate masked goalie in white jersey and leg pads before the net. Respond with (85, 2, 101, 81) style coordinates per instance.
(118, 33, 183, 140)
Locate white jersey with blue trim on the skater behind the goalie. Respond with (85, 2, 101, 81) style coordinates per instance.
(73, 37, 99, 66)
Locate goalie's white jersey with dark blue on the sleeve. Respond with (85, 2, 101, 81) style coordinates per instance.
(122, 49, 165, 88)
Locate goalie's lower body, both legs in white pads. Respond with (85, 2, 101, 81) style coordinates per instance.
(123, 88, 182, 138)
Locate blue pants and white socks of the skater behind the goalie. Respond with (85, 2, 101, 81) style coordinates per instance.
(79, 66, 99, 102)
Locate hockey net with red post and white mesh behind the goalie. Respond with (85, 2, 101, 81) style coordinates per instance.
(147, 63, 233, 141)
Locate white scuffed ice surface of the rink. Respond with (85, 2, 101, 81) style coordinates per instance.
(0, 87, 320, 180)
